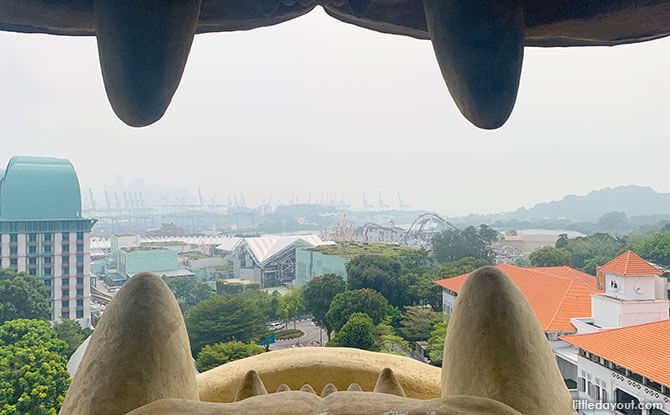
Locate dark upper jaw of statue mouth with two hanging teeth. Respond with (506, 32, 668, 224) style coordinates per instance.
(0, 0, 670, 129)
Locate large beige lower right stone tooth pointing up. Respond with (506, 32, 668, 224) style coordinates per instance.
(442, 267, 575, 414)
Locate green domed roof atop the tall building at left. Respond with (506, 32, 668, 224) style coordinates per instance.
(0, 156, 81, 219)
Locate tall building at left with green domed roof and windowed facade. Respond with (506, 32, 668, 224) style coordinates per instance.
(0, 156, 95, 327)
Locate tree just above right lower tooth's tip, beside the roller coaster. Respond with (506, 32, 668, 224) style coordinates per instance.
(432, 225, 498, 262)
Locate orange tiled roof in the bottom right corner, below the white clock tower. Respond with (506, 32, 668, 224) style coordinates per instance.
(561, 320, 670, 385)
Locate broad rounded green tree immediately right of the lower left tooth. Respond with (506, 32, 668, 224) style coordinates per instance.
(185, 295, 267, 354)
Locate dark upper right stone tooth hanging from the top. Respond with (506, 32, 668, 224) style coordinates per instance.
(423, 0, 525, 129)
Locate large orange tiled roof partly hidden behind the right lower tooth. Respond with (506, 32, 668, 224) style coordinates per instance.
(435, 264, 602, 331)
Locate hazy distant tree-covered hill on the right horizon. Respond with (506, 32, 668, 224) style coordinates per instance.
(510, 185, 670, 222)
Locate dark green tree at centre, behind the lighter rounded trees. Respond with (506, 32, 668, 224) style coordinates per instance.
(347, 255, 412, 307)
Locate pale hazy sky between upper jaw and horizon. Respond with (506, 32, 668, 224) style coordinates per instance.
(0, 8, 670, 215)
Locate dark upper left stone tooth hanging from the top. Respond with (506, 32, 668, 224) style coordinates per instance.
(94, 0, 202, 127)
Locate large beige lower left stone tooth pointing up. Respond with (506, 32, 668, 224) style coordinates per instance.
(60, 273, 199, 415)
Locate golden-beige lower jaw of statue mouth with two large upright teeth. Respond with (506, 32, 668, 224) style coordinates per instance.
(60, 267, 574, 415)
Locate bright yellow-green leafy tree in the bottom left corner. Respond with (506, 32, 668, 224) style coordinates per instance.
(0, 345, 70, 415)
